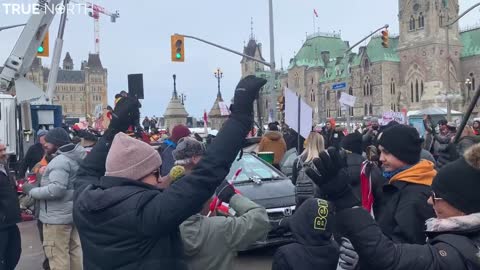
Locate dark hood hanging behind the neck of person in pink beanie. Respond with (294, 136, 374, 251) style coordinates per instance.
(78, 176, 156, 212)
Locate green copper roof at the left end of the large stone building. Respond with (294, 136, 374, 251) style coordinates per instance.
(288, 34, 347, 69)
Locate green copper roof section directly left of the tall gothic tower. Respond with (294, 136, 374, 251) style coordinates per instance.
(367, 37, 400, 63)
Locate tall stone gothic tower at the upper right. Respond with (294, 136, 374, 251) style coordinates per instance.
(398, 0, 462, 110)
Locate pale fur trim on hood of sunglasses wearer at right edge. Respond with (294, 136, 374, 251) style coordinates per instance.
(425, 213, 480, 232)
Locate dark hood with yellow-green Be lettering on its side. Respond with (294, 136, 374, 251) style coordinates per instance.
(287, 198, 335, 246)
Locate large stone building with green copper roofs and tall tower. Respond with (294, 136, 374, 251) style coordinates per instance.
(251, 0, 480, 123)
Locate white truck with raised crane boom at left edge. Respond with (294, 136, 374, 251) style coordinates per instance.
(0, 0, 64, 168)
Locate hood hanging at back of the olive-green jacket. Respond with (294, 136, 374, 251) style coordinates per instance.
(180, 214, 203, 257)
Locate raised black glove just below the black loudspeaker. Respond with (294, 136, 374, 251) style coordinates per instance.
(105, 97, 141, 141)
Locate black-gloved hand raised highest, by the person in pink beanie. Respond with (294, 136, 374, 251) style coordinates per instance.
(230, 75, 267, 116)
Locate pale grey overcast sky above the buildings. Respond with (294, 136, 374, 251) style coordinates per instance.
(0, 0, 480, 117)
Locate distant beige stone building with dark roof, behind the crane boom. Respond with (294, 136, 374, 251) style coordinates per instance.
(27, 52, 108, 117)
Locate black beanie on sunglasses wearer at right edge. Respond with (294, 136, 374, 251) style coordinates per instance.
(432, 144, 480, 215)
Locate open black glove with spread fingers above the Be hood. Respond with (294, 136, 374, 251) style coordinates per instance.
(306, 147, 360, 210)
